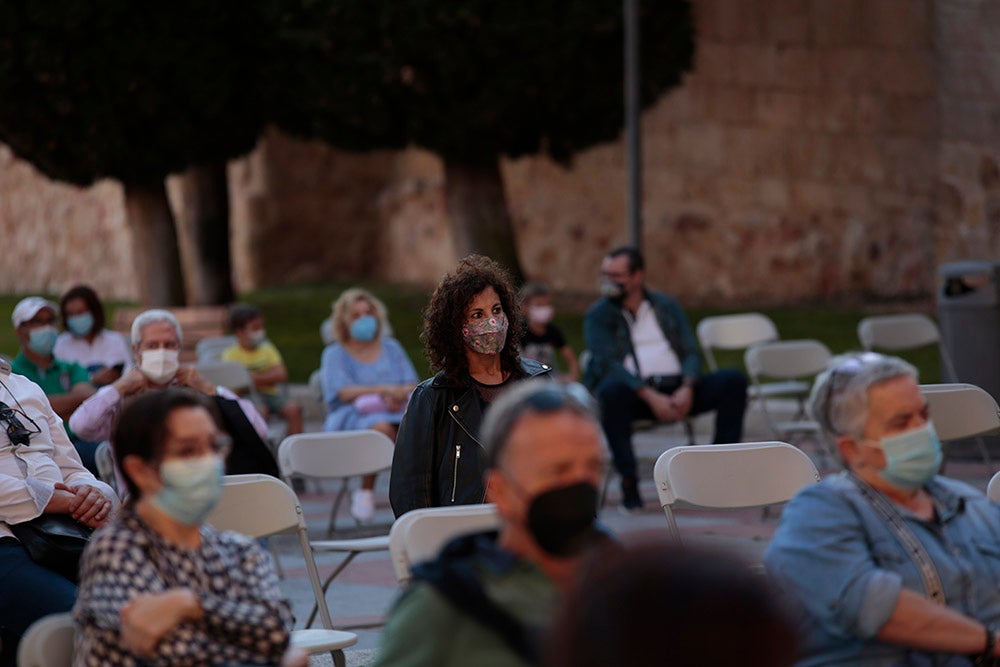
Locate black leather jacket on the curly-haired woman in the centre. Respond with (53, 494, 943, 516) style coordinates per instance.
(389, 359, 552, 517)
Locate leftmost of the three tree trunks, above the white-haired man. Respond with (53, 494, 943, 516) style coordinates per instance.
(125, 181, 184, 306)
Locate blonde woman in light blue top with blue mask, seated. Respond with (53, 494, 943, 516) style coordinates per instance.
(320, 287, 417, 523)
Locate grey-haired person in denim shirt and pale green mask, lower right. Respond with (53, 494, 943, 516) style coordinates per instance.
(765, 353, 1000, 666)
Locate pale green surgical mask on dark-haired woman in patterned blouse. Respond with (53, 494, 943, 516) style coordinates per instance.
(151, 454, 224, 526)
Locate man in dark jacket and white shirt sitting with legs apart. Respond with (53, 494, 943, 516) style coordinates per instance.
(583, 247, 747, 511)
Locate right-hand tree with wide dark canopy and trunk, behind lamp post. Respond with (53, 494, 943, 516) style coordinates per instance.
(276, 0, 694, 274)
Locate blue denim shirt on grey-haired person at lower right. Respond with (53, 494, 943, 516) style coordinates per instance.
(765, 473, 1000, 665)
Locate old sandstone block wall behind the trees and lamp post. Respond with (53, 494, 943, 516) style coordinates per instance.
(0, 0, 1000, 305)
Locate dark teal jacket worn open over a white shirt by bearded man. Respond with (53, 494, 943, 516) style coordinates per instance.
(583, 290, 701, 390)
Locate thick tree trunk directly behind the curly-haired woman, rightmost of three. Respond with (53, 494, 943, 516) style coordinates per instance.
(444, 159, 524, 284)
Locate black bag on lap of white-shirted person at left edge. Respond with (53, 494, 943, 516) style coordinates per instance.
(8, 514, 94, 583)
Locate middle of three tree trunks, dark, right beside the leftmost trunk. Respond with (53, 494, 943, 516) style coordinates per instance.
(169, 162, 233, 306)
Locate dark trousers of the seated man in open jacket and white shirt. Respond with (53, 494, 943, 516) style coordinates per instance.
(594, 368, 747, 478)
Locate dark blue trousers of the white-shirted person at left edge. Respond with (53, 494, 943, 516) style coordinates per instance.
(0, 538, 76, 667)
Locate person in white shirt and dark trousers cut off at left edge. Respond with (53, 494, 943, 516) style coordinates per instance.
(0, 368, 118, 667)
